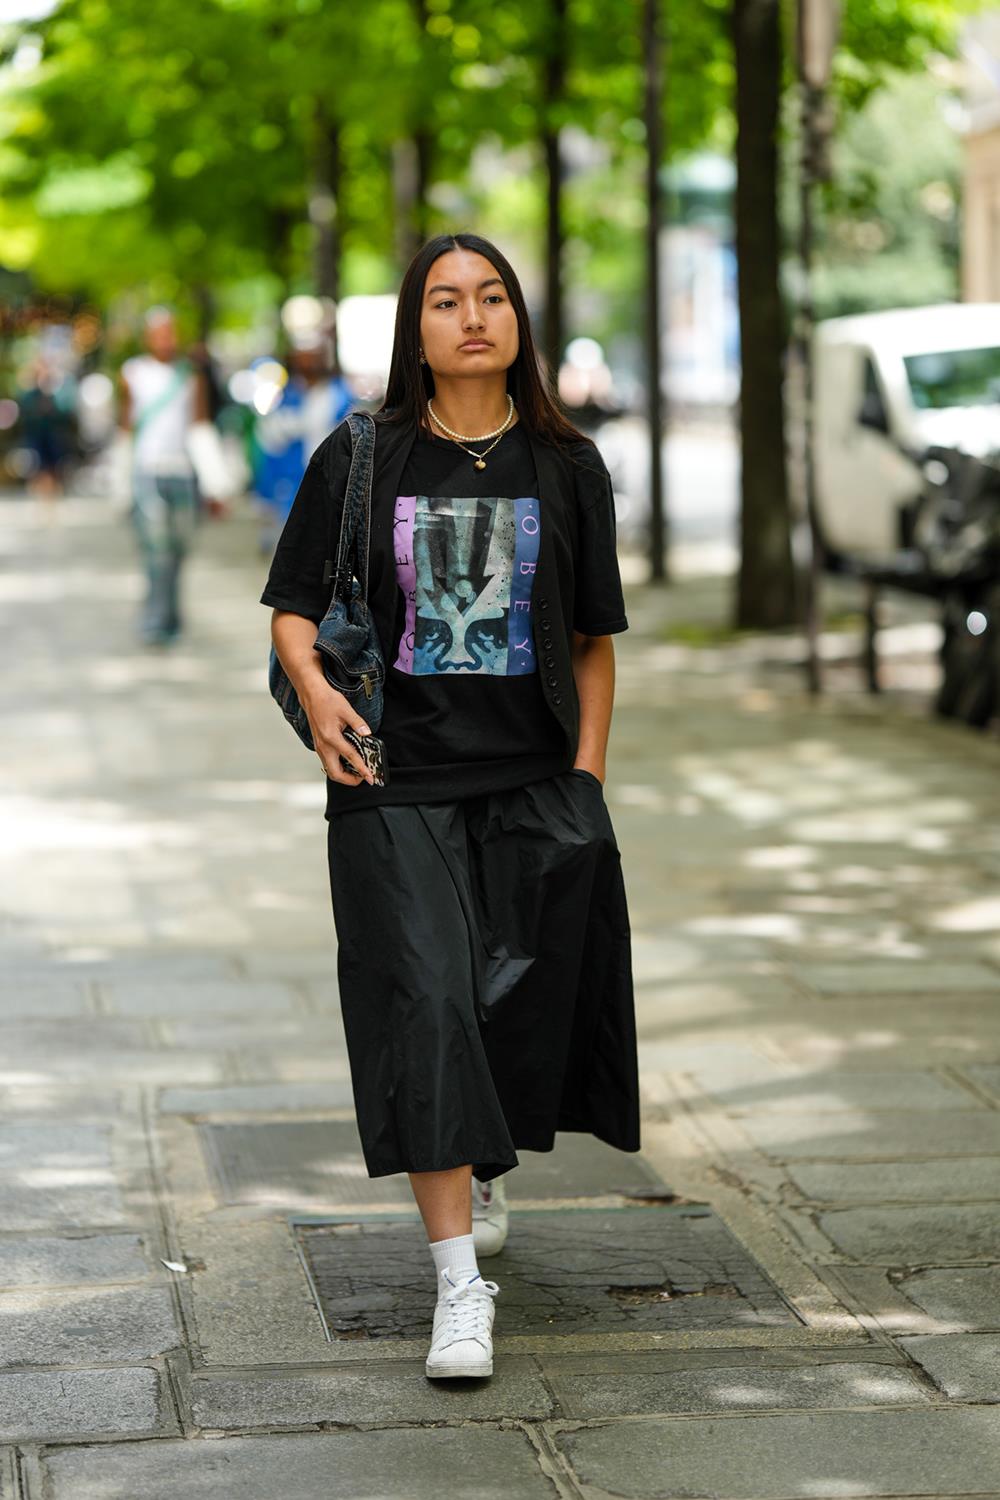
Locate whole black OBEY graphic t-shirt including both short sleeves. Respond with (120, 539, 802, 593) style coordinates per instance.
(261, 422, 628, 818)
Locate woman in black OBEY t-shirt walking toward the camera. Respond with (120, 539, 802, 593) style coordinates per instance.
(261, 234, 640, 1377)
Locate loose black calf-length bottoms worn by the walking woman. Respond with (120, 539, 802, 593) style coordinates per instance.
(328, 770, 640, 1182)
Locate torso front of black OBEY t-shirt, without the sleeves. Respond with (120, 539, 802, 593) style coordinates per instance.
(328, 423, 573, 812)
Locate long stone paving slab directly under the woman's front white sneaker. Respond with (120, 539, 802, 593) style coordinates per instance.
(187, 1362, 553, 1431)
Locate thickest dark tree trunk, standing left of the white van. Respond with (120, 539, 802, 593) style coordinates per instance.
(733, 0, 796, 629)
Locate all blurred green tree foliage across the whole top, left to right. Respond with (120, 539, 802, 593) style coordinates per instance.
(0, 0, 983, 336)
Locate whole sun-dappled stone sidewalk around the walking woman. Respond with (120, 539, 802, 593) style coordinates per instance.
(0, 486, 1000, 1500)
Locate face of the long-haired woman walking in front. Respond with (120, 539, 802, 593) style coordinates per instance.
(420, 251, 520, 377)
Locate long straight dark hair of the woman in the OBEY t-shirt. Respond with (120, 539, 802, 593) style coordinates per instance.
(373, 231, 594, 459)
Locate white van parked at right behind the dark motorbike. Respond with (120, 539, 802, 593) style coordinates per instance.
(813, 303, 1000, 561)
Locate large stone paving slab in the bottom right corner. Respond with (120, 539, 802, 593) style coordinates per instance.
(558, 1407, 1000, 1500)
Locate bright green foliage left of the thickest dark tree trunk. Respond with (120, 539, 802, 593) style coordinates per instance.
(0, 0, 730, 316)
